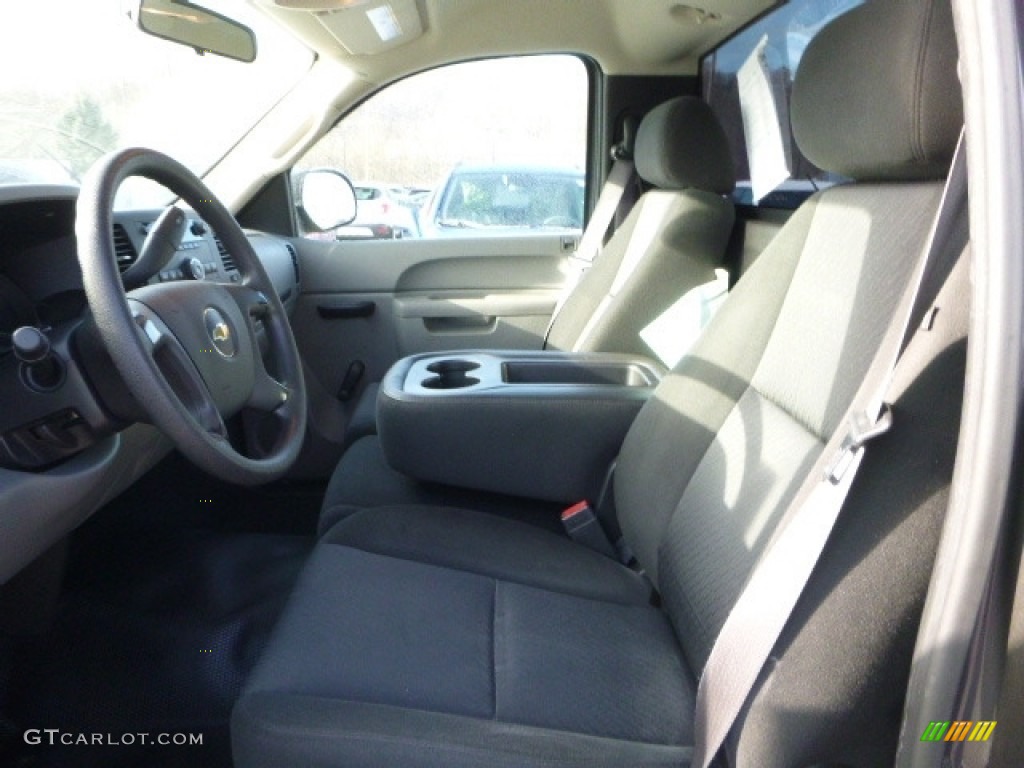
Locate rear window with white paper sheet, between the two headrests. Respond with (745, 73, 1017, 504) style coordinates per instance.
(700, 0, 863, 208)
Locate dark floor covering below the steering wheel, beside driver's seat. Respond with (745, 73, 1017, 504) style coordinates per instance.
(0, 456, 323, 768)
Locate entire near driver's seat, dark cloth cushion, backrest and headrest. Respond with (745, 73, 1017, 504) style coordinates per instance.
(231, 0, 968, 768)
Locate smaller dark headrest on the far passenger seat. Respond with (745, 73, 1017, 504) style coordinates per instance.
(634, 96, 736, 195)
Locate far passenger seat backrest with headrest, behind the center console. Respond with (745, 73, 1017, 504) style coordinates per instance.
(547, 96, 735, 356)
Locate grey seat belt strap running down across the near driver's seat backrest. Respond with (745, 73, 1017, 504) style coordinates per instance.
(690, 131, 967, 768)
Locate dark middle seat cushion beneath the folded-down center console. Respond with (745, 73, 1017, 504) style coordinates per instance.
(318, 435, 564, 535)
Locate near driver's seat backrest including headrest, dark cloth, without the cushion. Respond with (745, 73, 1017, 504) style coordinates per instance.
(614, 0, 963, 766)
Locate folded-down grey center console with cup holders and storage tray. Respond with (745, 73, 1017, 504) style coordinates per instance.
(377, 351, 663, 502)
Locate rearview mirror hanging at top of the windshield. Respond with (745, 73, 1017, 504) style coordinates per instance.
(134, 0, 256, 63)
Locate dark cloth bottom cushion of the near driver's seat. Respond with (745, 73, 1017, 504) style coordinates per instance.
(231, 507, 695, 766)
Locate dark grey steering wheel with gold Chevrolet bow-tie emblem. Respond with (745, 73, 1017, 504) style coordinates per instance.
(75, 148, 306, 484)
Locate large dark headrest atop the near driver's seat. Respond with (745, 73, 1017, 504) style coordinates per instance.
(791, 0, 964, 181)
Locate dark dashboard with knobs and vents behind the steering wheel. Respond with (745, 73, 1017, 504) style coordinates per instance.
(0, 185, 299, 583)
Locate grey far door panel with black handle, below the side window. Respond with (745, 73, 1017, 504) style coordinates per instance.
(292, 234, 574, 428)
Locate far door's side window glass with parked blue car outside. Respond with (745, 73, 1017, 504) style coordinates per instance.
(293, 55, 590, 240)
